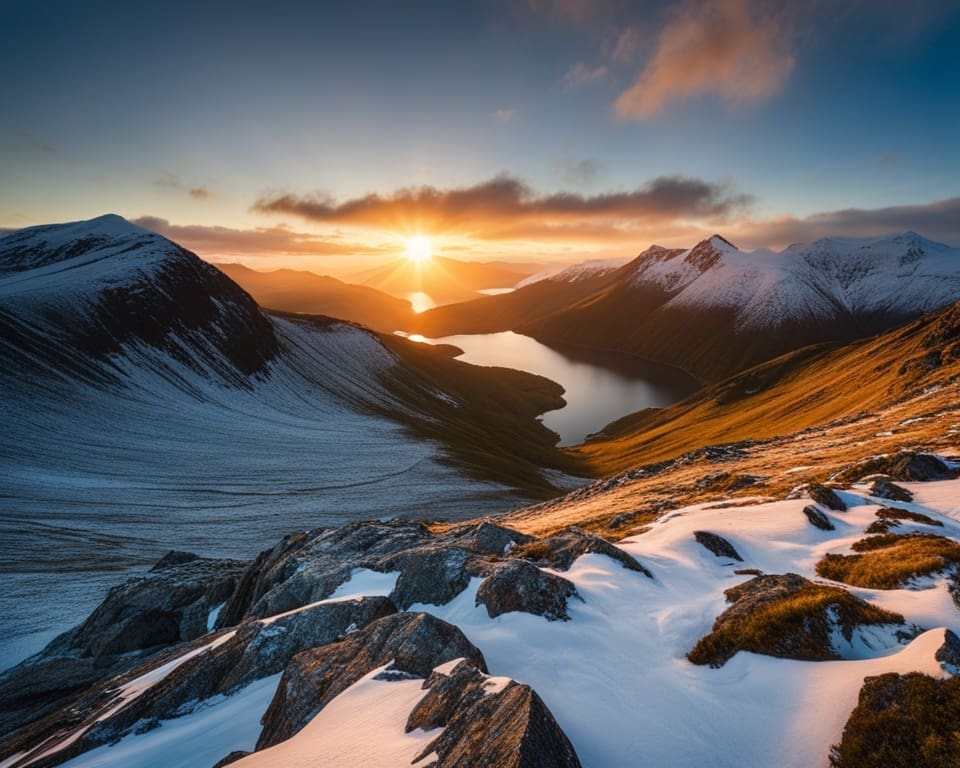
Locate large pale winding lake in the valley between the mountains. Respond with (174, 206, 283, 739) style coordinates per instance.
(420, 331, 700, 445)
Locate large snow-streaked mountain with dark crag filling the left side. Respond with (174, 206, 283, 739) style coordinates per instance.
(0, 216, 576, 666)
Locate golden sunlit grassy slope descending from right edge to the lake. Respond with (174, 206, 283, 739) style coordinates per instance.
(571, 303, 960, 473)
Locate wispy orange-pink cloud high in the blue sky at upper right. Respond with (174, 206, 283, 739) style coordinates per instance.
(616, 0, 794, 119)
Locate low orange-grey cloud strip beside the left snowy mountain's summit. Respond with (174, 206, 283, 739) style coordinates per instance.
(133, 216, 389, 256)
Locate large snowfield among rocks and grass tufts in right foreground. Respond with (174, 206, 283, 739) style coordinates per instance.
(411, 481, 960, 768)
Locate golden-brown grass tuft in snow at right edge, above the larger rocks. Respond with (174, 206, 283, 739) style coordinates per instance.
(817, 533, 960, 589)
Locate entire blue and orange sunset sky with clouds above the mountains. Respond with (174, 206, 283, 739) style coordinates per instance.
(0, 0, 960, 272)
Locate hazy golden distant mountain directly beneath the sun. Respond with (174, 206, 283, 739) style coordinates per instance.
(350, 256, 531, 304)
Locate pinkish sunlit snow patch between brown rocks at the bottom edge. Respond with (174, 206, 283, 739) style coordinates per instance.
(235, 665, 441, 768)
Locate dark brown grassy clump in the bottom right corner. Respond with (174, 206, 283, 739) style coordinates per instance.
(830, 672, 960, 768)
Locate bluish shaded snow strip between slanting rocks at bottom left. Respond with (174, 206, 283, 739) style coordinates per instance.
(63, 674, 280, 768)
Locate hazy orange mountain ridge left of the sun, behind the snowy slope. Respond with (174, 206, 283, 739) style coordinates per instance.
(216, 264, 413, 333)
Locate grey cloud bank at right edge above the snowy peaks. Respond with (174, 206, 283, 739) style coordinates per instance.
(736, 197, 960, 248)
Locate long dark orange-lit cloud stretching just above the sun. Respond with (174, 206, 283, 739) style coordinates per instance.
(252, 175, 752, 238)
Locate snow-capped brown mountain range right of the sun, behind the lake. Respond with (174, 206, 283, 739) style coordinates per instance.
(415, 232, 960, 382)
